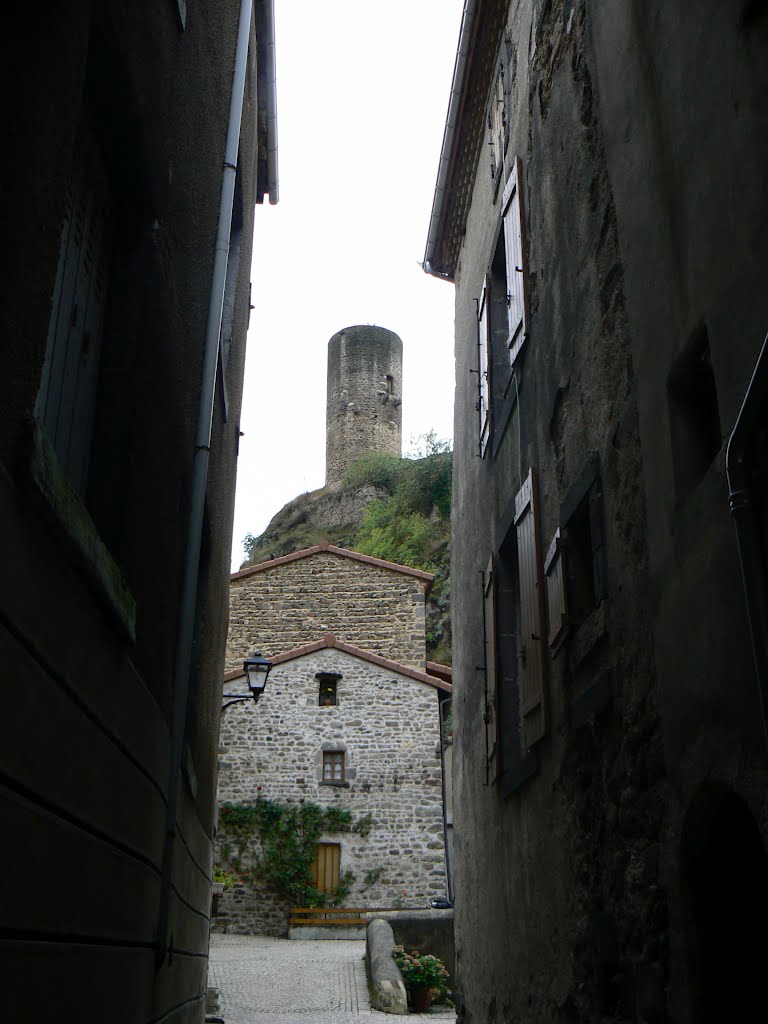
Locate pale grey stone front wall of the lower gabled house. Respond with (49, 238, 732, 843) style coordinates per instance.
(214, 648, 445, 934)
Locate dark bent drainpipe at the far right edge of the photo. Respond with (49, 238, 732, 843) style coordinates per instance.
(725, 336, 768, 748)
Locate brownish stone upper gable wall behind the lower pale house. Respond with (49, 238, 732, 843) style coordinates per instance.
(226, 551, 426, 682)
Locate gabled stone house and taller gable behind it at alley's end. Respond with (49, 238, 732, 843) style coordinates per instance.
(215, 545, 451, 934)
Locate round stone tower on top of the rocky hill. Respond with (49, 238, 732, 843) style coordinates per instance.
(326, 326, 402, 485)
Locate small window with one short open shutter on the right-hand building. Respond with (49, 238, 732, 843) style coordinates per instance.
(544, 452, 606, 653)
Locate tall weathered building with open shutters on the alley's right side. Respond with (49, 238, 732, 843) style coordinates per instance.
(425, 0, 768, 1024)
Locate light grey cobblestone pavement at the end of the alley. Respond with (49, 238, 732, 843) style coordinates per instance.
(208, 935, 456, 1024)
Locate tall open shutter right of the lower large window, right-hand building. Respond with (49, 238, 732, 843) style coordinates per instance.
(515, 469, 547, 750)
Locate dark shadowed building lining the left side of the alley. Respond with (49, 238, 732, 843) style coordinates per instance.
(0, 0, 278, 1024)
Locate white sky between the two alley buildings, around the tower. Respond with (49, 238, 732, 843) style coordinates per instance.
(232, 0, 463, 568)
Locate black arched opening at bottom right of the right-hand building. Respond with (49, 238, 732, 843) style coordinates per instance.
(680, 783, 768, 1024)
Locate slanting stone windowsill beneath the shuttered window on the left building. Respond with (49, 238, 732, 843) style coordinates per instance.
(29, 420, 136, 642)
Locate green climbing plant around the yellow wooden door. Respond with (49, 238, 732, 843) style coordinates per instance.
(219, 797, 364, 906)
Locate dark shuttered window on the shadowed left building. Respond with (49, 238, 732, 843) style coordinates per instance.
(35, 117, 112, 494)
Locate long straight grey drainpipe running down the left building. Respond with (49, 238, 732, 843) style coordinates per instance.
(157, 0, 253, 964)
